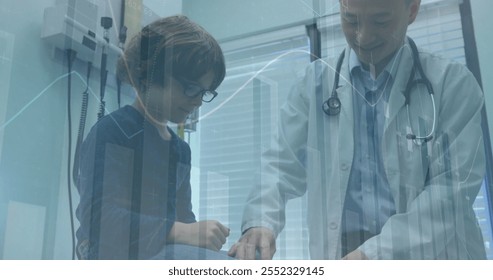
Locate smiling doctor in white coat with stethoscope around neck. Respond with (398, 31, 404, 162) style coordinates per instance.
(229, 0, 485, 259)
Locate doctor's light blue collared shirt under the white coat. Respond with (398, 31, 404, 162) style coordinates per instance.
(343, 50, 399, 235)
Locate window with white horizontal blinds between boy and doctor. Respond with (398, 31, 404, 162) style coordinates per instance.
(195, 26, 310, 259)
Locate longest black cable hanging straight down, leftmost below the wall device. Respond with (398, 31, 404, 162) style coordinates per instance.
(67, 49, 77, 260)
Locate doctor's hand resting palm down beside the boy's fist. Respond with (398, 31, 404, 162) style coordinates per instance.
(228, 227, 276, 260)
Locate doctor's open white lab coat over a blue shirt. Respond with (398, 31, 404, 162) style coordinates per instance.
(242, 42, 485, 259)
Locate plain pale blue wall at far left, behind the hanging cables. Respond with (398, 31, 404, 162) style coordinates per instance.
(0, 0, 133, 259)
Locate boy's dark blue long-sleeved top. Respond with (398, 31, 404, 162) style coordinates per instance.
(76, 106, 196, 259)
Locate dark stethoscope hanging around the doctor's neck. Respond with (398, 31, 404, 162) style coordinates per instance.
(322, 38, 436, 145)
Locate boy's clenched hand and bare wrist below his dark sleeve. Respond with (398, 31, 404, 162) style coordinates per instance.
(167, 220, 229, 251)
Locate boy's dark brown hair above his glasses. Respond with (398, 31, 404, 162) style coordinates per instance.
(117, 15, 226, 92)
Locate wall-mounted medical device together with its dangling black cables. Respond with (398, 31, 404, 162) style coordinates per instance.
(41, 0, 126, 259)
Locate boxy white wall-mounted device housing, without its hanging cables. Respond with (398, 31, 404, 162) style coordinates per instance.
(41, 0, 122, 72)
